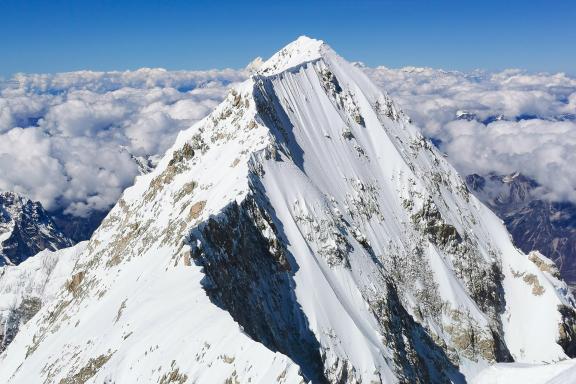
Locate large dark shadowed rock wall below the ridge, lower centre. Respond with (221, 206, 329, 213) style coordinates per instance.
(188, 195, 326, 383)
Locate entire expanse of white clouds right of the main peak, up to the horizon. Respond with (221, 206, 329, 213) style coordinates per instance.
(364, 67, 576, 202)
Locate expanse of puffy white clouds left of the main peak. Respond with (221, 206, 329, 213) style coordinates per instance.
(0, 69, 246, 216)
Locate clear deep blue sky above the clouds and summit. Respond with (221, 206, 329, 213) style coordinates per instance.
(0, 0, 576, 77)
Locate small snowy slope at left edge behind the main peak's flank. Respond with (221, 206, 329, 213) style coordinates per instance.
(0, 242, 86, 351)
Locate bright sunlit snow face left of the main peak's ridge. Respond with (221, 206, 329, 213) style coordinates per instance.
(0, 60, 301, 383)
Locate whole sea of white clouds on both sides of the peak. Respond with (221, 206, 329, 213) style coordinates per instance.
(0, 67, 576, 216)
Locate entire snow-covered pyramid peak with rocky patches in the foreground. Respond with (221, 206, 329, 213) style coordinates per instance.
(0, 37, 576, 383)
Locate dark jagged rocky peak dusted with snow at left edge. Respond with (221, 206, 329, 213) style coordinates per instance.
(0, 192, 72, 266)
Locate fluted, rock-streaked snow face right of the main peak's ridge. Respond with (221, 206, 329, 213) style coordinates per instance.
(246, 42, 571, 378)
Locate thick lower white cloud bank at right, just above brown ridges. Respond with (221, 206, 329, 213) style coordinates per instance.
(443, 119, 576, 201)
